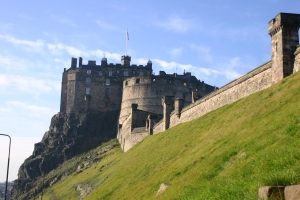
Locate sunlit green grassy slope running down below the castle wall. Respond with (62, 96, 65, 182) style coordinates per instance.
(42, 73, 300, 199)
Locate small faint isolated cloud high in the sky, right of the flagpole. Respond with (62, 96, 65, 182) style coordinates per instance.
(156, 15, 196, 33)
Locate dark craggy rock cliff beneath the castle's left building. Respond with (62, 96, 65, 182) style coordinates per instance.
(12, 111, 118, 199)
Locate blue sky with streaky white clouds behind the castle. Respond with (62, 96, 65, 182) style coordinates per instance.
(0, 0, 300, 182)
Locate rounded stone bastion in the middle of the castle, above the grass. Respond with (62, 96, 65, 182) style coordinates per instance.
(118, 72, 215, 151)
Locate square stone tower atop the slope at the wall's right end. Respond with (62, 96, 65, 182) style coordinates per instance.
(268, 13, 300, 84)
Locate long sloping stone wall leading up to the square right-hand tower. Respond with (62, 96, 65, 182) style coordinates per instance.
(166, 61, 272, 133)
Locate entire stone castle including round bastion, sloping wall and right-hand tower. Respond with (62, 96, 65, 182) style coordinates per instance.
(60, 13, 300, 151)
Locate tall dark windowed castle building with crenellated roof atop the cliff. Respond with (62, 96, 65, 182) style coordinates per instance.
(60, 56, 152, 113)
